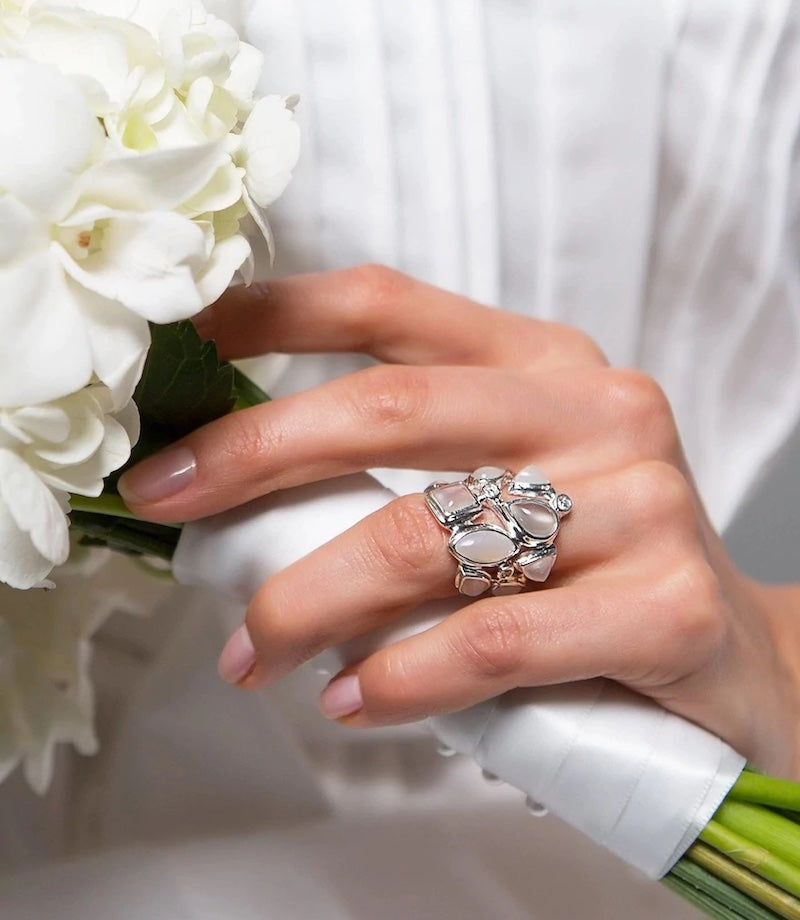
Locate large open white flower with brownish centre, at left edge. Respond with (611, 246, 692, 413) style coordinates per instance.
(0, 59, 236, 406)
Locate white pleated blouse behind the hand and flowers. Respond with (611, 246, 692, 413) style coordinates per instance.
(239, 0, 800, 528)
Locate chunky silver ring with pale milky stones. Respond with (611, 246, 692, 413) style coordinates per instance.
(425, 466, 572, 597)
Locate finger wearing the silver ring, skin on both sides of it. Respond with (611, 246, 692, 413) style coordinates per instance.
(225, 465, 671, 687)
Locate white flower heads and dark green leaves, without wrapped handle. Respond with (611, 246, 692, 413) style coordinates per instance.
(0, 0, 299, 790)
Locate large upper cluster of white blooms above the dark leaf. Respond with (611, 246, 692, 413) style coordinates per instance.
(0, 6, 299, 405)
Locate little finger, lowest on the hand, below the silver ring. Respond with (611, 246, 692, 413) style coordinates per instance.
(320, 574, 698, 728)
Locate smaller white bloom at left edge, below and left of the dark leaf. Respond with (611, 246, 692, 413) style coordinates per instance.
(0, 384, 138, 588)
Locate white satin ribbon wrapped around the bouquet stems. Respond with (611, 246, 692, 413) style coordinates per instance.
(173, 474, 744, 878)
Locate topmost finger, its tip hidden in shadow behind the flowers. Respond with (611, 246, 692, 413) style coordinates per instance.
(195, 265, 605, 369)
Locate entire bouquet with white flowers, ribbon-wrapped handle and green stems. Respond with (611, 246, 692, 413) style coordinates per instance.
(0, 0, 800, 920)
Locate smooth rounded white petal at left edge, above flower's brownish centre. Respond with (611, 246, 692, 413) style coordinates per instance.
(0, 58, 103, 221)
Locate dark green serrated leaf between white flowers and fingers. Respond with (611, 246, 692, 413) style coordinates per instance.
(133, 320, 236, 438)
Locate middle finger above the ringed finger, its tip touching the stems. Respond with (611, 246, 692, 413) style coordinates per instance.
(119, 365, 663, 522)
